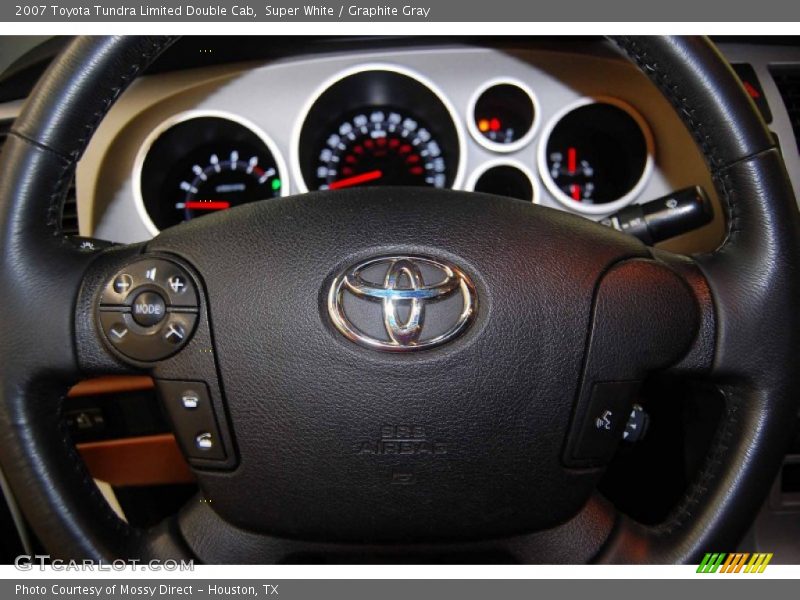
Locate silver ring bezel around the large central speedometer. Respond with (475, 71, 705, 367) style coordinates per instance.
(290, 62, 467, 193)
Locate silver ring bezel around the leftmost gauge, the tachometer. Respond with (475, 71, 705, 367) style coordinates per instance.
(132, 109, 290, 236)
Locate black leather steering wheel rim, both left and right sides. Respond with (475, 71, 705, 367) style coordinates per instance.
(0, 37, 800, 563)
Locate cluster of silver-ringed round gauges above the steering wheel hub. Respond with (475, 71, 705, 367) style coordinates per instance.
(133, 64, 654, 234)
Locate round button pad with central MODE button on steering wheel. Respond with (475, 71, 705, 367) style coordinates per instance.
(98, 258, 199, 362)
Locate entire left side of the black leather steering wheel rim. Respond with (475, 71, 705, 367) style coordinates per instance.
(0, 39, 186, 559)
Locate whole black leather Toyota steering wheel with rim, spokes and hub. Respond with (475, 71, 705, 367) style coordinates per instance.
(0, 37, 800, 563)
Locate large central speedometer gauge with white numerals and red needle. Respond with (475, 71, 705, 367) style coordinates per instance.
(295, 65, 464, 191)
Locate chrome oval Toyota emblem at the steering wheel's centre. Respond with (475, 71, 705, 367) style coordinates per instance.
(328, 256, 477, 352)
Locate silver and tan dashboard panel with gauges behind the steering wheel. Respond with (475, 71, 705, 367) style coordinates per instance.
(77, 42, 736, 251)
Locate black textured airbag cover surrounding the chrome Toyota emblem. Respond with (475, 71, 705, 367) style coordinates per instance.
(147, 188, 648, 542)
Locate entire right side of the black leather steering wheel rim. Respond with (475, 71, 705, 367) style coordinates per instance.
(601, 37, 800, 563)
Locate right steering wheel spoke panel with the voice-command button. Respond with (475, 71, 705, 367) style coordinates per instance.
(564, 257, 709, 467)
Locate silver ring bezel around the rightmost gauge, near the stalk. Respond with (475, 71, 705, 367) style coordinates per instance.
(536, 96, 655, 216)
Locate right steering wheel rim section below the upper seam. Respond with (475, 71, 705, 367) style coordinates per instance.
(604, 150, 800, 562)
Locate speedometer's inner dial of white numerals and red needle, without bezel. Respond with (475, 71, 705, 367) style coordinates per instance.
(316, 109, 447, 190)
